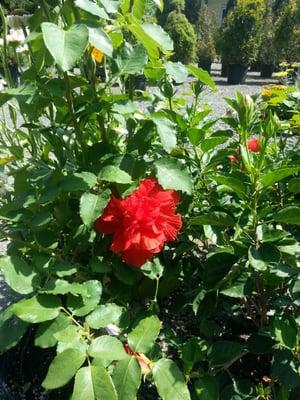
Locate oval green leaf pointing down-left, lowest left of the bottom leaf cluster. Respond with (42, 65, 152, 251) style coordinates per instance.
(42, 349, 86, 390)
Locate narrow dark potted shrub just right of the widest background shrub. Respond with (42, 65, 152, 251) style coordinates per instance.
(257, 1, 277, 78)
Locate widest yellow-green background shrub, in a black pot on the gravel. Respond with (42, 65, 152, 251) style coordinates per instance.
(221, 0, 264, 84)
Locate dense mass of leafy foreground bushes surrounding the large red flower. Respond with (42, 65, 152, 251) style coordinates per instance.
(0, 0, 300, 400)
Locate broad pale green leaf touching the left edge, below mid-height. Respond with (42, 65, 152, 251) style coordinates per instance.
(0, 256, 39, 294)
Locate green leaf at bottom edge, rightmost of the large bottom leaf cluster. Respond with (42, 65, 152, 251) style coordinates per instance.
(152, 358, 191, 400)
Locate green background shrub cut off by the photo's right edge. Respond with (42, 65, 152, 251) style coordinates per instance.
(275, 0, 300, 62)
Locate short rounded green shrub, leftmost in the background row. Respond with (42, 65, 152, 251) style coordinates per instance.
(164, 11, 196, 64)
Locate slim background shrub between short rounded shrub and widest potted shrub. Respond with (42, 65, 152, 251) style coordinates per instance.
(196, 4, 216, 72)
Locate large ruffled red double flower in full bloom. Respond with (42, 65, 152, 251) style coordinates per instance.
(96, 179, 182, 267)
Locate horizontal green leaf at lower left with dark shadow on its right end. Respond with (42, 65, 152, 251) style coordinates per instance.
(12, 295, 61, 324)
